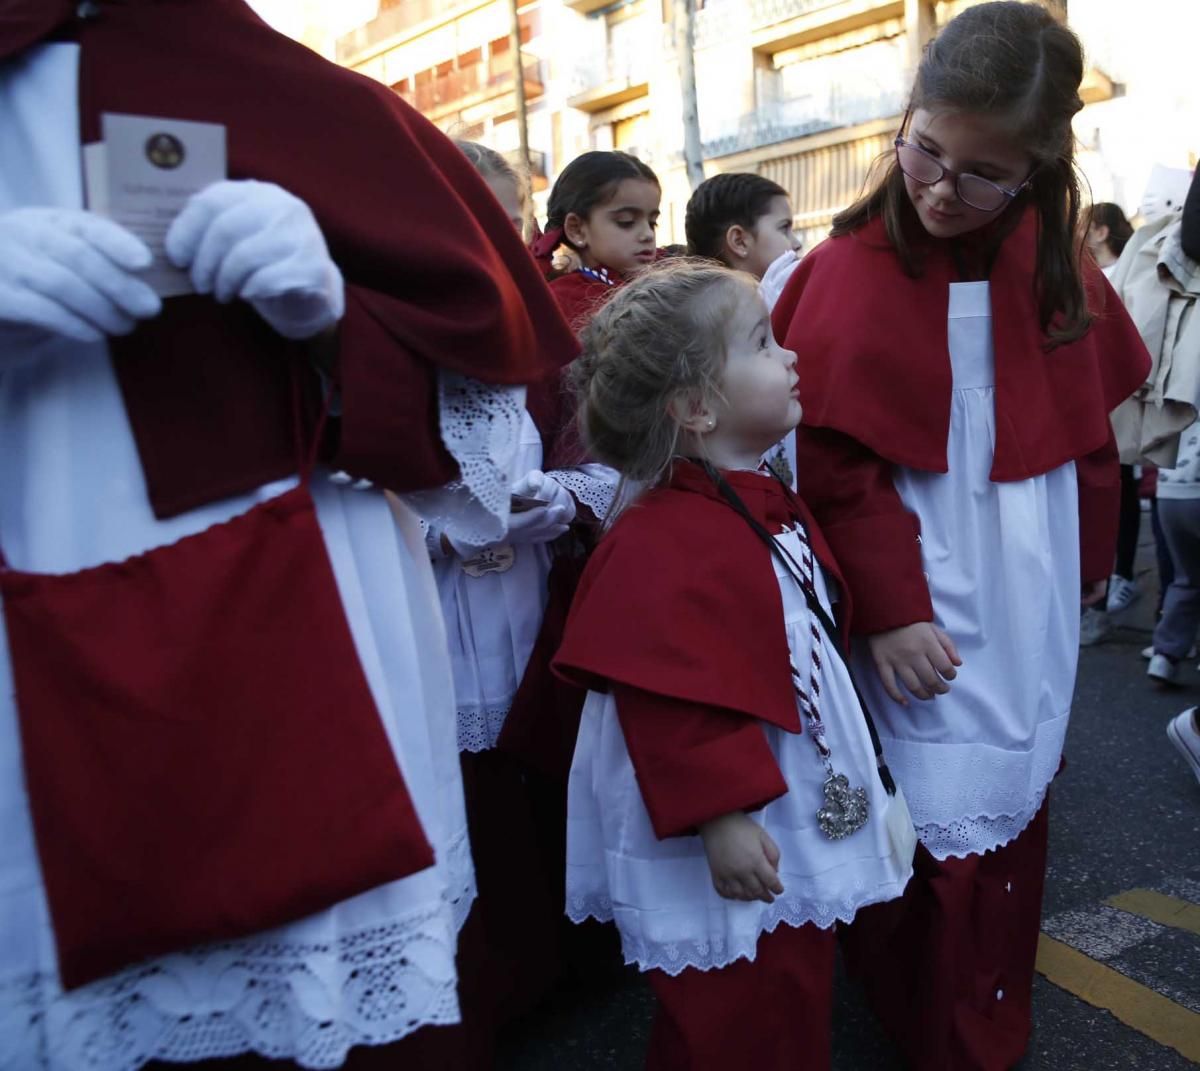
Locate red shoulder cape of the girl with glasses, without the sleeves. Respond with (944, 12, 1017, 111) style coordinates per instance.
(773, 213, 1150, 480)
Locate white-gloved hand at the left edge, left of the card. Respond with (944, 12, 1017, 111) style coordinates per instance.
(0, 208, 162, 342)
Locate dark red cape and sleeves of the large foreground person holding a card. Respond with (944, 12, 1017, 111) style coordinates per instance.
(0, 0, 577, 516)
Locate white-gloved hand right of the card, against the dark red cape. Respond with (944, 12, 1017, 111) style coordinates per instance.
(166, 179, 346, 339)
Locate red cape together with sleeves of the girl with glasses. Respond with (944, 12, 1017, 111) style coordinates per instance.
(773, 207, 1150, 633)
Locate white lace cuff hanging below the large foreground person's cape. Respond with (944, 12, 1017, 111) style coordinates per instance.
(403, 370, 526, 546)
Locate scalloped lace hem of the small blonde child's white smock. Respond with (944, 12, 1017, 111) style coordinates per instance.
(566, 870, 912, 977)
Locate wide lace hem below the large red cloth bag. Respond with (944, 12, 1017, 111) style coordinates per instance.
(0, 907, 460, 1071)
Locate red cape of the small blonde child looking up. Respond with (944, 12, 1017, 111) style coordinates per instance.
(553, 461, 850, 732)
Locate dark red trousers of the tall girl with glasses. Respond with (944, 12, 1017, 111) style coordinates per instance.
(841, 803, 1048, 1071)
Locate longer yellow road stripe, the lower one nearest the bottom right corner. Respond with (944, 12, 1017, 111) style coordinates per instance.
(1038, 933, 1200, 1063)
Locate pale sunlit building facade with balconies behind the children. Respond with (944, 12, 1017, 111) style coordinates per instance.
(336, 0, 1185, 246)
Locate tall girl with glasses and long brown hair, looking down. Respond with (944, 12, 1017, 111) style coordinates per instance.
(774, 2, 1148, 1071)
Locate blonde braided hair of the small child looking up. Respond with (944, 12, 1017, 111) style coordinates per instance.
(570, 258, 756, 487)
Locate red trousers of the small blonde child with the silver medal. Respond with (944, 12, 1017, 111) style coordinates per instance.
(646, 923, 835, 1071)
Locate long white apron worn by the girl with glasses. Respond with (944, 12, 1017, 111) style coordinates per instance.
(856, 282, 1080, 858)
